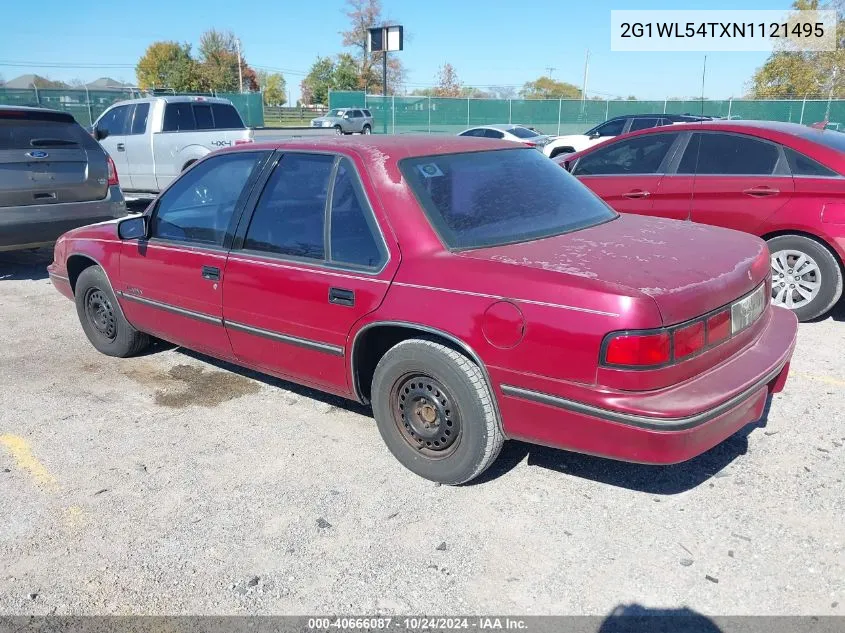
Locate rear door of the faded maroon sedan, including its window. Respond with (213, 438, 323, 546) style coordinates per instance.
(223, 152, 398, 395)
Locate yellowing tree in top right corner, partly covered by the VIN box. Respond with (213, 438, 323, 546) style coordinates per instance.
(751, 0, 845, 99)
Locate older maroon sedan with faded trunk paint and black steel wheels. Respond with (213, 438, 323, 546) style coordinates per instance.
(49, 136, 797, 484)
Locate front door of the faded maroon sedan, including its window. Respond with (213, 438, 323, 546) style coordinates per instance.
(119, 151, 270, 358)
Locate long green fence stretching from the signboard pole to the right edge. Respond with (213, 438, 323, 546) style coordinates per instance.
(329, 91, 845, 134)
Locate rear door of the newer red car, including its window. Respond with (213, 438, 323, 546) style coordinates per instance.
(676, 131, 794, 233)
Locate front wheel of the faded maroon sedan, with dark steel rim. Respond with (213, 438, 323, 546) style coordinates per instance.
(74, 266, 150, 358)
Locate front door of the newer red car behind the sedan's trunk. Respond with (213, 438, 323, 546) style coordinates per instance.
(572, 132, 686, 219)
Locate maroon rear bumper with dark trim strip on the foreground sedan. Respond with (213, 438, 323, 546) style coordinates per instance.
(499, 308, 798, 464)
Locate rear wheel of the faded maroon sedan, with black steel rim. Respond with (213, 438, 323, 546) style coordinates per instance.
(372, 339, 504, 485)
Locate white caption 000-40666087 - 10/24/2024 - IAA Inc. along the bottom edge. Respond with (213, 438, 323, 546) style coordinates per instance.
(307, 616, 527, 631)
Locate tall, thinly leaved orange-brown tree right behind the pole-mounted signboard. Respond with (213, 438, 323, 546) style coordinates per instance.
(341, 0, 405, 94)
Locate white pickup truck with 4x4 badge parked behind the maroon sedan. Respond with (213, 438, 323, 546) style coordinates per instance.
(91, 97, 253, 194)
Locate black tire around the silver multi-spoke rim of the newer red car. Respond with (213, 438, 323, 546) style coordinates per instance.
(768, 235, 842, 321)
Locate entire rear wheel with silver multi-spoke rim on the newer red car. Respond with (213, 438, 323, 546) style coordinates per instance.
(768, 235, 842, 321)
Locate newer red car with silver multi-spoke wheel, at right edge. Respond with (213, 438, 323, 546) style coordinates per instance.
(554, 121, 845, 321)
